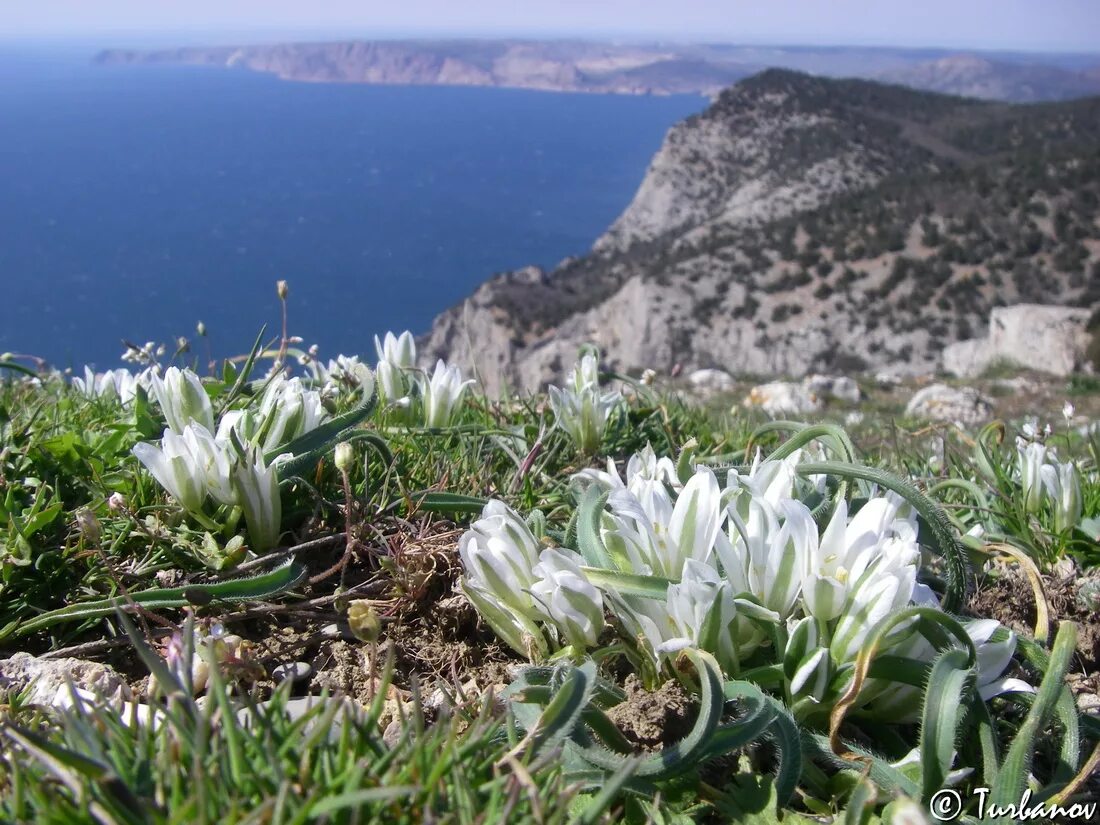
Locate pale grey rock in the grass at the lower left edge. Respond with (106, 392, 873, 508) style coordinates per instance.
(0, 653, 131, 705)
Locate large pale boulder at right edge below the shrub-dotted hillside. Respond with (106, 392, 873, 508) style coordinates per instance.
(942, 304, 1091, 377)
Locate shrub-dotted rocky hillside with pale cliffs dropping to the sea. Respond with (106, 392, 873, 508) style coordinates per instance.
(422, 70, 1100, 388)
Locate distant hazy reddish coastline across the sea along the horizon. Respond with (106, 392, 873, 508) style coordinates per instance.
(96, 40, 1100, 101)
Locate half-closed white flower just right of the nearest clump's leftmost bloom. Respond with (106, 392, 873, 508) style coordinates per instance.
(530, 548, 604, 650)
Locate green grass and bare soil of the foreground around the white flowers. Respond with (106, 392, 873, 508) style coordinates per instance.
(0, 325, 1100, 823)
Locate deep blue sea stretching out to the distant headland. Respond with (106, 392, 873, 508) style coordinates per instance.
(0, 45, 705, 367)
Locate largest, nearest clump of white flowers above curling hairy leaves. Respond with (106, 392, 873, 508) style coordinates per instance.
(460, 449, 1026, 714)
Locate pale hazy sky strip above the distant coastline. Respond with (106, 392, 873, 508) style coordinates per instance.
(0, 0, 1100, 52)
